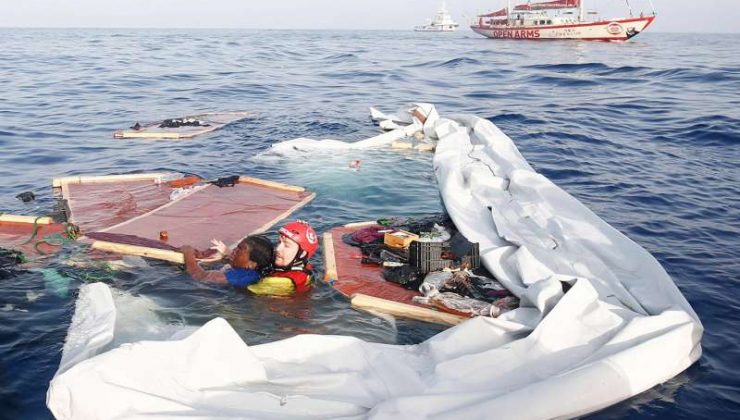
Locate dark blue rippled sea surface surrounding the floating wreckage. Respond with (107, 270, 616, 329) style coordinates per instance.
(0, 29, 740, 419)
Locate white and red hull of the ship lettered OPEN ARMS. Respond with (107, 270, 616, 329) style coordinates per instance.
(470, 16, 655, 41)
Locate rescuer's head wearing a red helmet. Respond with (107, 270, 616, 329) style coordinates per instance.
(275, 220, 319, 267)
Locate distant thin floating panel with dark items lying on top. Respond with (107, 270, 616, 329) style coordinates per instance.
(113, 112, 253, 139)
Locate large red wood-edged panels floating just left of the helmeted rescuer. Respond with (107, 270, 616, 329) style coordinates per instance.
(54, 173, 315, 263)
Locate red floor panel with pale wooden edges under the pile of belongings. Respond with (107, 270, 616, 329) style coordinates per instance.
(323, 222, 470, 325)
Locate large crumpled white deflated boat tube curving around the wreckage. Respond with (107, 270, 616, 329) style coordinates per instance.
(47, 105, 703, 419)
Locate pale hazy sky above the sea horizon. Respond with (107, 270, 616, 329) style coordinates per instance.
(0, 0, 740, 33)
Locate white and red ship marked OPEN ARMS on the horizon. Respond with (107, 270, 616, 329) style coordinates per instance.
(470, 0, 655, 41)
